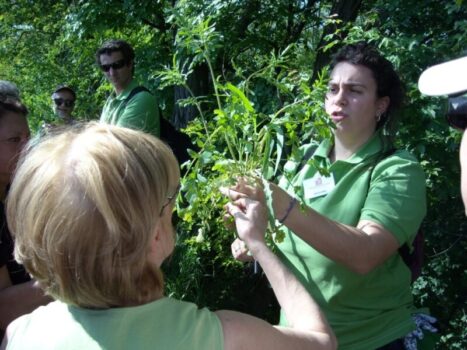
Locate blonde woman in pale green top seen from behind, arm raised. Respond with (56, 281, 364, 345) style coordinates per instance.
(3, 124, 336, 350)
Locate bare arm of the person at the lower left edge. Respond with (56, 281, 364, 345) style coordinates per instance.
(0, 266, 51, 330)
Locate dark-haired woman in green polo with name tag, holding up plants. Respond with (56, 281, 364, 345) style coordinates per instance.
(229, 42, 436, 349)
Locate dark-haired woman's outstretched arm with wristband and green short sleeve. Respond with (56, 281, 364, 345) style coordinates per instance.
(231, 160, 425, 274)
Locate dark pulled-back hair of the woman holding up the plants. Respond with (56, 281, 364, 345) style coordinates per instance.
(331, 41, 404, 136)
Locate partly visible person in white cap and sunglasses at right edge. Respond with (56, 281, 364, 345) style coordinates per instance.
(418, 56, 467, 216)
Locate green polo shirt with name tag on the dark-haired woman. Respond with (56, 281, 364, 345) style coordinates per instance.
(278, 133, 426, 350)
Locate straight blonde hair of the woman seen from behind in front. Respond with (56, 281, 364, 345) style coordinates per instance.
(7, 123, 180, 308)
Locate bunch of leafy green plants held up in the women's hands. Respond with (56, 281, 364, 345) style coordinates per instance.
(156, 18, 329, 230)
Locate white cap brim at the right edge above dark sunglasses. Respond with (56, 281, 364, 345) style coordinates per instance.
(418, 56, 467, 96)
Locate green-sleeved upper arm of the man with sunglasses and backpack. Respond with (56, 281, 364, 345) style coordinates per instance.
(117, 91, 160, 136)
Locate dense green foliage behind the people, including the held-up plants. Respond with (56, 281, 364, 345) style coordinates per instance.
(0, 0, 467, 349)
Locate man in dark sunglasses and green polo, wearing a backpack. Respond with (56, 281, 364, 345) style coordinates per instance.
(96, 40, 160, 136)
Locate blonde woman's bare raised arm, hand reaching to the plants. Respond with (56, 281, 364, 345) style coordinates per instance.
(217, 198, 337, 350)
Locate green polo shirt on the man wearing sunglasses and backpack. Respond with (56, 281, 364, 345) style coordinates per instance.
(100, 80, 160, 137)
